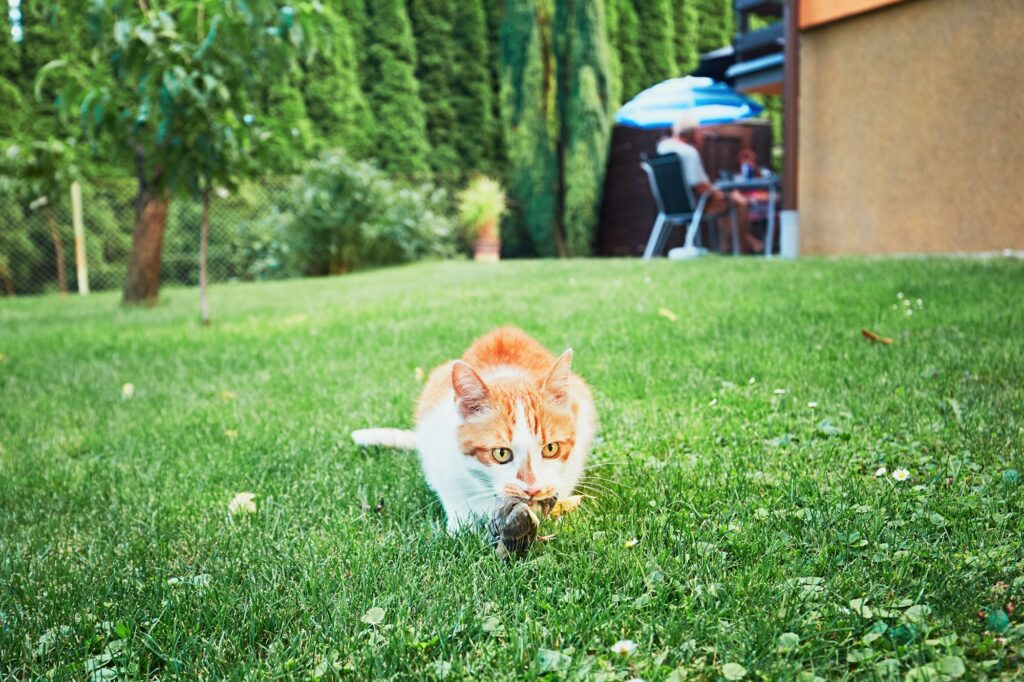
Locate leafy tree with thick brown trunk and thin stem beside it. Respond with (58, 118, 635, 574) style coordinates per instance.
(44, 0, 321, 313)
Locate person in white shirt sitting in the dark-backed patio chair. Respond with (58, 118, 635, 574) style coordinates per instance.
(657, 112, 764, 253)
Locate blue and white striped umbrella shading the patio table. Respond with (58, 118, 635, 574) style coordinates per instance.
(615, 76, 764, 128)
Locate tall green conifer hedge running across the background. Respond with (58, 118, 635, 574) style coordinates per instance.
(0, 0, 745, 292)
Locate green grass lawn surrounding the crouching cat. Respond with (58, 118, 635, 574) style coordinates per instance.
(0, 258, 1024, 681)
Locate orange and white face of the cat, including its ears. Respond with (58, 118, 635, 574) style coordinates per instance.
(452, 351, 575, 500)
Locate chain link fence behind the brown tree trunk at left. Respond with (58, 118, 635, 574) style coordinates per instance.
(0, 177, 298, 296)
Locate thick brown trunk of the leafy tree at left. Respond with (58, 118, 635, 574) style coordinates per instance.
(121, 152, 168, 305)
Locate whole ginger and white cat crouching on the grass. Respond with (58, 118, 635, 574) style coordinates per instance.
(352, 328, 596, 532)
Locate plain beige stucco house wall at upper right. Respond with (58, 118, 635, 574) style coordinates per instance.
(799, 0, 1024, 254)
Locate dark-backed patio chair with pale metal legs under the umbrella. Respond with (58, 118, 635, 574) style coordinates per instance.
(640, 154, 739, 260)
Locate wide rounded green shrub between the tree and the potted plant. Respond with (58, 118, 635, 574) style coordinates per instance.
(288, 152, 457, 274)
